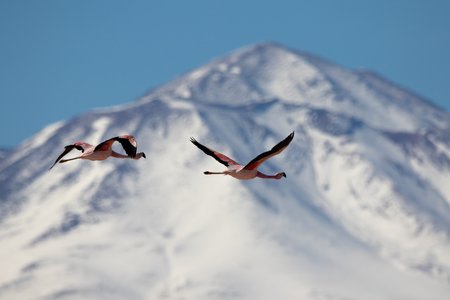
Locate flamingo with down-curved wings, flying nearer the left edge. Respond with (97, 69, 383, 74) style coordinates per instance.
(50, 135, 146, 169)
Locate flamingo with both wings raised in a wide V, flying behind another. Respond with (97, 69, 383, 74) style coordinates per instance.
(191, 132, 294, 180)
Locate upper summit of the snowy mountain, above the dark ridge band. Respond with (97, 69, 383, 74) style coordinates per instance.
(139, 42, 450, 131)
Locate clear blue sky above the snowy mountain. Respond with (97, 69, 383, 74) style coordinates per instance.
(0, 0, 450, 147)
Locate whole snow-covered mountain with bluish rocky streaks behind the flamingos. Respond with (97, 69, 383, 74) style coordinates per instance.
(0, 44, 450, 300)
